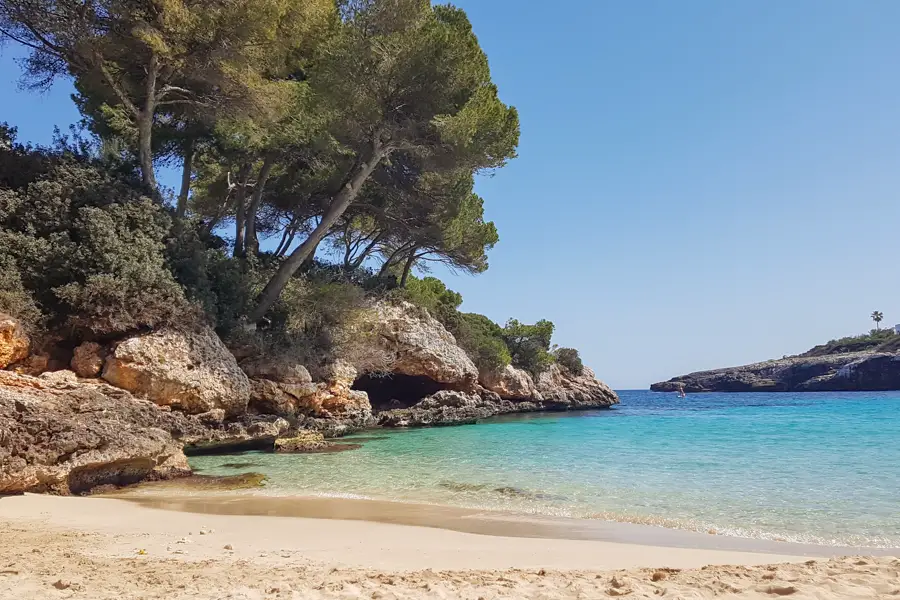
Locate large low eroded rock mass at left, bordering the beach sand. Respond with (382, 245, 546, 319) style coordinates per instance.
(0, 372, 190, 494)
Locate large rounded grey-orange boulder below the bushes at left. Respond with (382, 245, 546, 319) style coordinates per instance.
(102, 329, 250, 416)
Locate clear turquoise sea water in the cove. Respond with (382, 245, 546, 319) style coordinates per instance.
(191, 391, 900, 547)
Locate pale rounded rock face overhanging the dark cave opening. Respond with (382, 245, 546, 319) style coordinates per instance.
(371, 302, 478, 392)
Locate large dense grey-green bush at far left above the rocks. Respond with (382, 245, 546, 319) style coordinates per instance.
(0, 131, 189, 338)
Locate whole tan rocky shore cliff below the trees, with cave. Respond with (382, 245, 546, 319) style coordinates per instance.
(0, 303, 618, 494)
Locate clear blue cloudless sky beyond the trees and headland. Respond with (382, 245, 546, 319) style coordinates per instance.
(0, 0, 900, 389)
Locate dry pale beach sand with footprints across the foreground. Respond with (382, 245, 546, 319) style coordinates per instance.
(0, 495, 900, 600)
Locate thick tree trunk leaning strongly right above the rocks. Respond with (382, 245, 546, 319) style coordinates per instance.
(248, 146, 386, 323)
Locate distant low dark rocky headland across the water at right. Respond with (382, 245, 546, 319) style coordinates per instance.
(650, 352, 900, 393)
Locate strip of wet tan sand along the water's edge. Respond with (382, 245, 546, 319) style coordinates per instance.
(109, 488, 900, 557)
